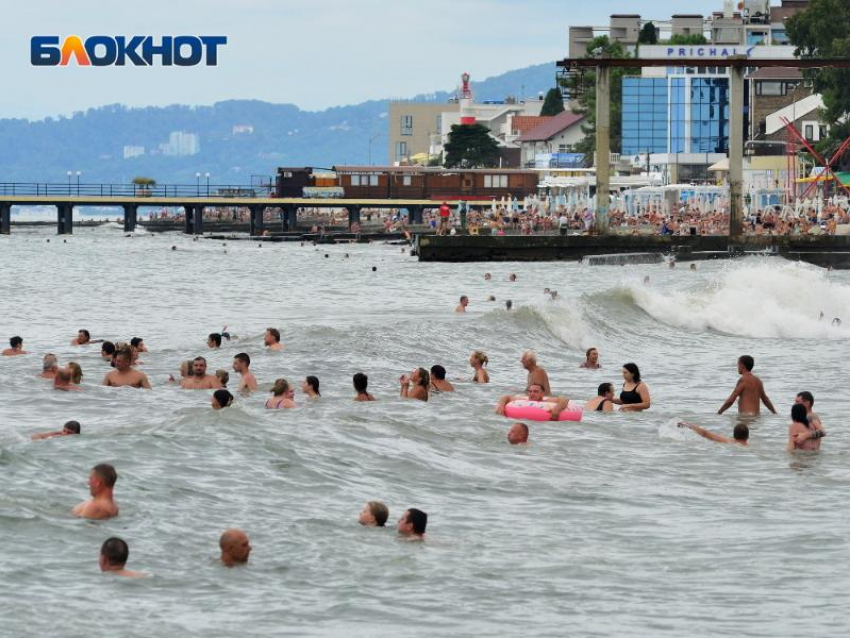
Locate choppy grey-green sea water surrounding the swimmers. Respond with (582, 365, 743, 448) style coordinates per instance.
(0, 224, 850, 637)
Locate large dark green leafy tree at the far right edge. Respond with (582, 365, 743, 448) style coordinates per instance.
(785, 0, 850, 168)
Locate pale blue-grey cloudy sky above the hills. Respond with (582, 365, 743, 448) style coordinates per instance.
(0, 0, 708, 119)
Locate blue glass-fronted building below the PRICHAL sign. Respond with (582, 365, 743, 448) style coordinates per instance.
(621, 69, 729, 155)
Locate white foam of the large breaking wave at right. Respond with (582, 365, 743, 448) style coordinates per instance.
(627, 262, 850, 339)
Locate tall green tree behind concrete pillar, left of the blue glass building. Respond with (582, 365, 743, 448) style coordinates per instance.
(570, 35, 629, 167)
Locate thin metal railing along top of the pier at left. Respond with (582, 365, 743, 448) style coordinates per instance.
(0, 182, 272, 199)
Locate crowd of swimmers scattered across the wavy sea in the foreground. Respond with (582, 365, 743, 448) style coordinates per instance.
(2, 318, 826, 577)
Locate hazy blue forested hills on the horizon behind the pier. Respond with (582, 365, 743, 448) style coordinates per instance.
(0, 63, 555, 184)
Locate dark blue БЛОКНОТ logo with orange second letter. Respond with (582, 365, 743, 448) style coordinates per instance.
(30, 35, 227, 66)
